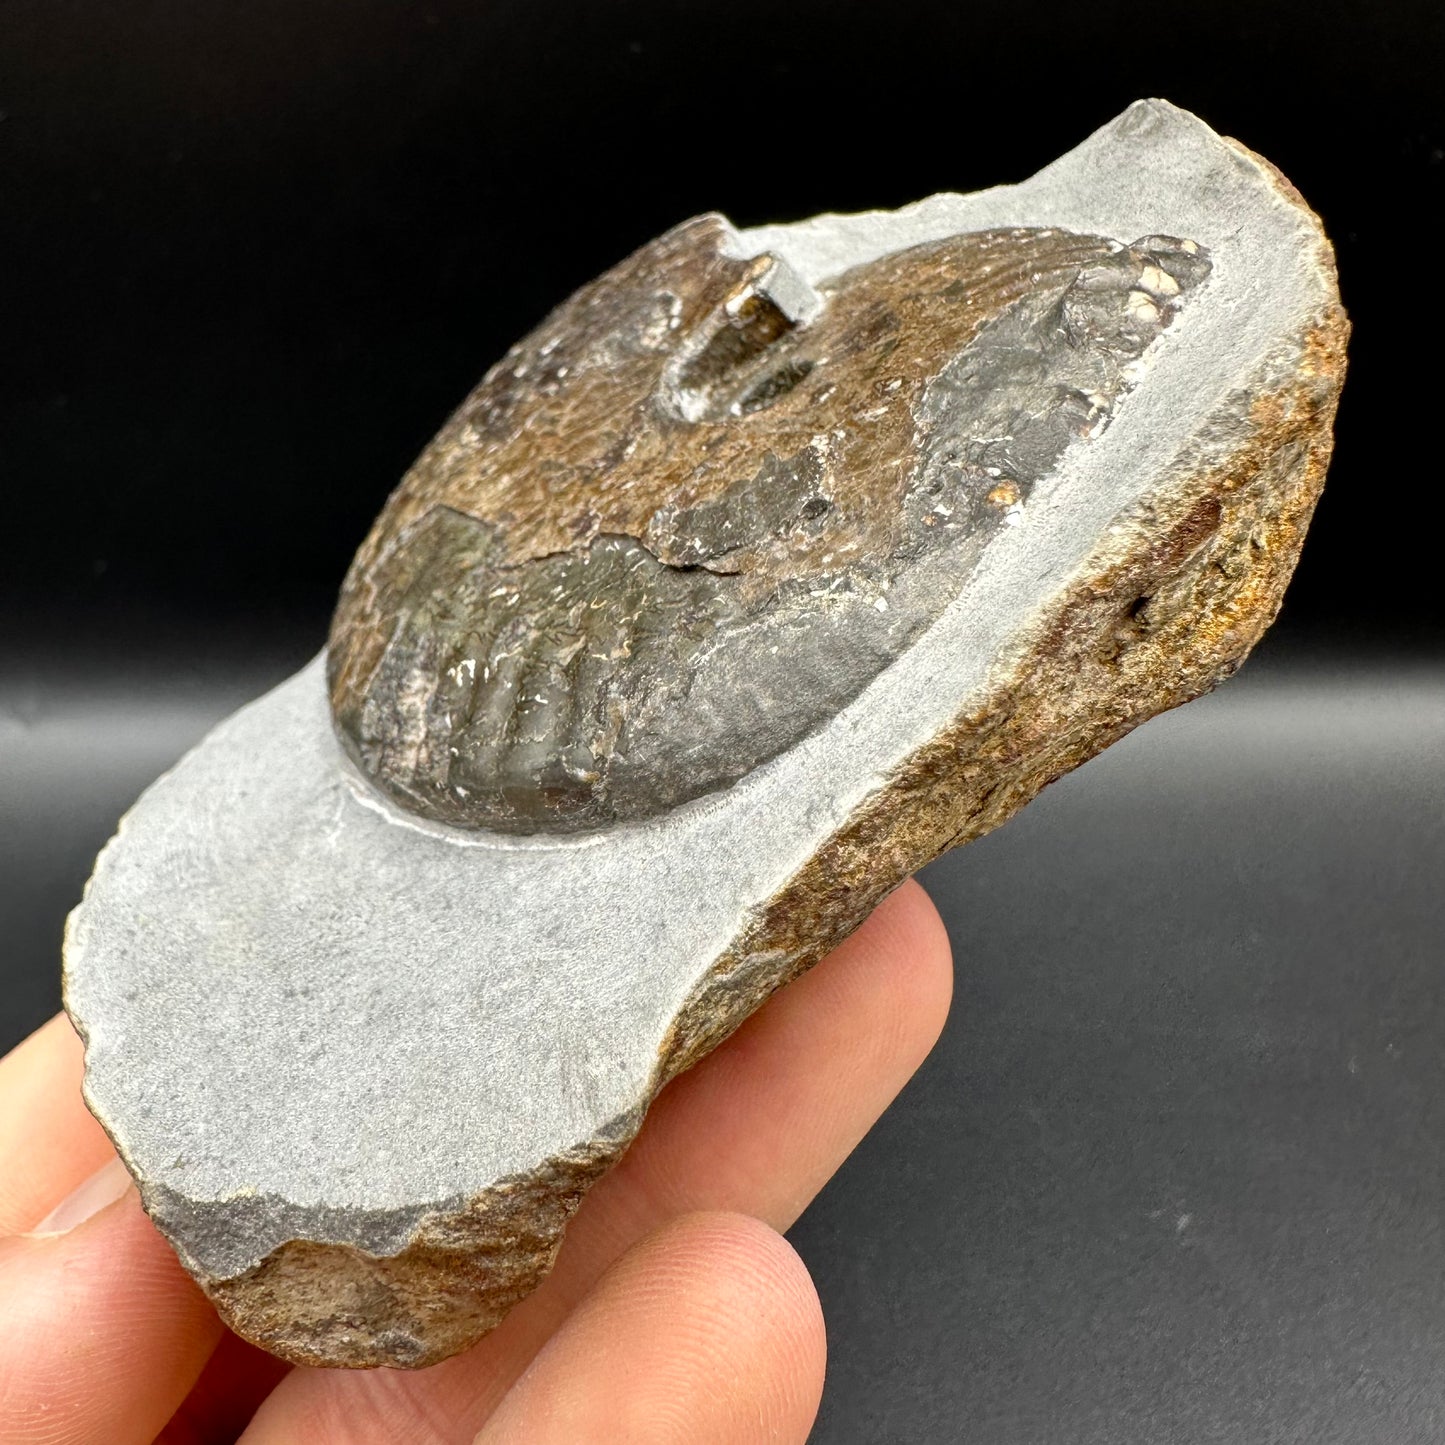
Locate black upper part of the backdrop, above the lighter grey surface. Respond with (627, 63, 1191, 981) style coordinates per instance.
(8, 0, 1445, 644)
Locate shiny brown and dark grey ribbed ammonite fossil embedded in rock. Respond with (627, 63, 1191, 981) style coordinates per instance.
(328, 217, 1209, 832)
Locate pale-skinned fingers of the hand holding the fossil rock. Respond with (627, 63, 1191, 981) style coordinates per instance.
(0, 883, 952, 1445)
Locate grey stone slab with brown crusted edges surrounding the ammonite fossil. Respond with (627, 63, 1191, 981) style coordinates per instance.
(56, 101, 1347, 1366)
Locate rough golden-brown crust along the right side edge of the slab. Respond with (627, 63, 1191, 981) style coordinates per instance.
(663, 299, 1350, 1077)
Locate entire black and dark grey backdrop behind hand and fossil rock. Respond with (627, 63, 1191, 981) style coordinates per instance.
(0, 0, 1445, 1442)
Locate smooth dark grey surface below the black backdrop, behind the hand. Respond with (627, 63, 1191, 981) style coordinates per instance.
(0, 649, 1445, 1445)
